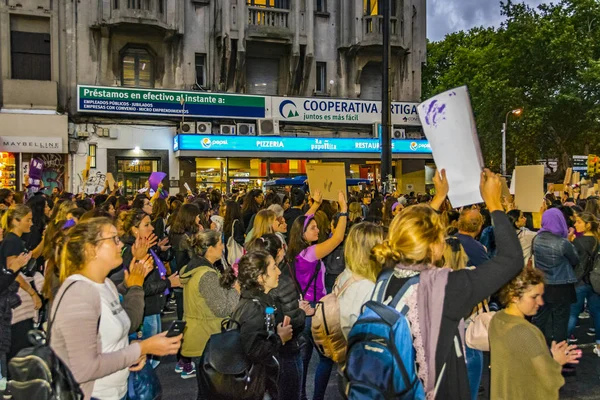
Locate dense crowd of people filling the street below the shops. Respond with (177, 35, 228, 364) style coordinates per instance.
(0, 170, 600, 400)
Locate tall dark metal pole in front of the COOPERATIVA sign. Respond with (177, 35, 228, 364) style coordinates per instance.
(379, 0, 392, 192)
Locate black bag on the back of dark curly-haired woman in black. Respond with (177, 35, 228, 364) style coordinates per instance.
(197, 319, 266, 400)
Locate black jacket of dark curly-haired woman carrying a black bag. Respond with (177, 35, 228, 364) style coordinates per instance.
(232, 290, 283, 400)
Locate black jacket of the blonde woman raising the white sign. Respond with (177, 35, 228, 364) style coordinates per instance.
(385, 211, 523, 400)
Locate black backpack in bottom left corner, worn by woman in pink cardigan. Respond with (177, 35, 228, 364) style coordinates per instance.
(8, 282, 83, 400)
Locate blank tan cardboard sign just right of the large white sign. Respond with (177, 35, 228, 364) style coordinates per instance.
(515, 165, 544, 212)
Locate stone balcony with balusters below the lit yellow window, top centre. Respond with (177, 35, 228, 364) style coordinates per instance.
(248, 6, 293, 40)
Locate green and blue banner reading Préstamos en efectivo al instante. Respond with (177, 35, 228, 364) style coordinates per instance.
(77, 85, 266, 119)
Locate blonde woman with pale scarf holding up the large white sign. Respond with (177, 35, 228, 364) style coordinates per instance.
(360, 170, 522, 399)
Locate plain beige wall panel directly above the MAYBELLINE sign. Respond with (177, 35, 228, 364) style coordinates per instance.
(2, 79, 58, 110)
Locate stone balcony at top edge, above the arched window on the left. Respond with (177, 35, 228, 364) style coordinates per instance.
(95, 0, 184, 34)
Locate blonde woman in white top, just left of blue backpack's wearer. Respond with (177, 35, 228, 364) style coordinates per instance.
(333, 222, 383, 338)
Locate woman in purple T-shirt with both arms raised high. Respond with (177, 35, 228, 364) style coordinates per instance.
(287, 191, 348, 400)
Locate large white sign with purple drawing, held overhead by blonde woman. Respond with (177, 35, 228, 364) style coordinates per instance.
(418, 86, 483, 207)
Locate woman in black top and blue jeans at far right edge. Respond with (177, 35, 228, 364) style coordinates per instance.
(568, 212, 600, 346)
